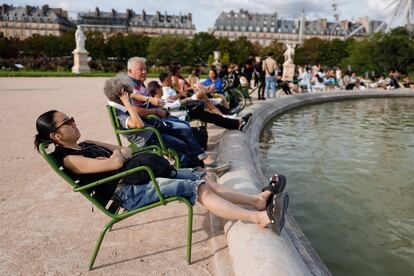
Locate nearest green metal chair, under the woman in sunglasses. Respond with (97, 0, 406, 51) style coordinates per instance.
(39, 142, 193, 270)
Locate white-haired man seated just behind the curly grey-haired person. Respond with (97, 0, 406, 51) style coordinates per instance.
(128, 57, 251, 130)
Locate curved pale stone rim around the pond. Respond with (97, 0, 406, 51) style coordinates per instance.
(212, 89, 414, 276)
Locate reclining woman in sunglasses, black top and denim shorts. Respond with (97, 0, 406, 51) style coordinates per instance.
(34, 110, 289, 235)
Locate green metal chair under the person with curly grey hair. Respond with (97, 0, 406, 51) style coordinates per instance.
(106, 105, 180, 169)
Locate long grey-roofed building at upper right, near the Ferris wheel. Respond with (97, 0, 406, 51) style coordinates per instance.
(209, 9, 381, 46)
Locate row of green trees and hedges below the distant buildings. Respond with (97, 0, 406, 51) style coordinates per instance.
(0, 28, 414, 74)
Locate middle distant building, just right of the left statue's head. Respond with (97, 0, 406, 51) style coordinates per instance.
(77, 8, 196, 37)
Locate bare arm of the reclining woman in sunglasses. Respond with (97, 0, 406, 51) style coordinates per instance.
(63, 149, 125, 174)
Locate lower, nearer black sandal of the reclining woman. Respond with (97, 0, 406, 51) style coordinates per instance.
(266, 193, 289, 236)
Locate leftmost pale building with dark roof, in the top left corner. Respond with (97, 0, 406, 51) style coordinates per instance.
(0, 4, 75, 39)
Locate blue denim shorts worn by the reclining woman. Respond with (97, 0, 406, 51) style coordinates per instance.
(115, 169, 205, 210)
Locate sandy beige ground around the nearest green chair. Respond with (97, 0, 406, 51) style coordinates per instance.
(0, 78, 226, 275)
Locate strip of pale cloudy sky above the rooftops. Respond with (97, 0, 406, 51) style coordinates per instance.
(8, 0, 398, 32)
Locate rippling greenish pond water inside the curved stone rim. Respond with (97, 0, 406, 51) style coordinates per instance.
(260, 98, 414, 275)
